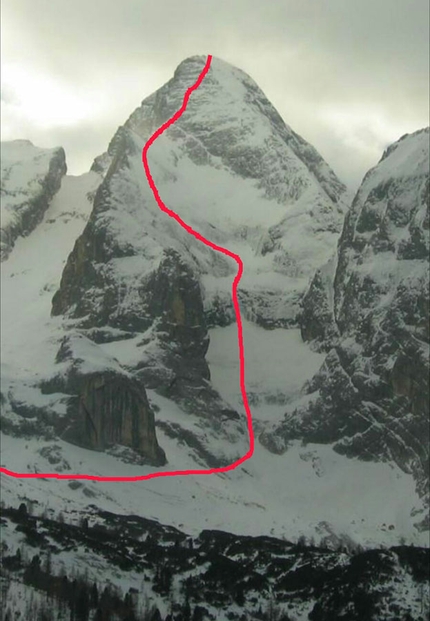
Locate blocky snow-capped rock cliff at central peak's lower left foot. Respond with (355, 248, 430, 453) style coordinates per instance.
(42, 334, 166, 466)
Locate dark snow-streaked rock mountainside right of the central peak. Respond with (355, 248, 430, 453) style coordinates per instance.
(266, 129, 429, 512)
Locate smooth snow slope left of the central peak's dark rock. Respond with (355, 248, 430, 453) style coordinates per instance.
(0, 172, 100, 429)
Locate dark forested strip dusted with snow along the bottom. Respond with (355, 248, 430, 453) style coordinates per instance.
(1, 503, 429, 621)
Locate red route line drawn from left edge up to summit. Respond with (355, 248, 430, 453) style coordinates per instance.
(0, 55, 255, 481)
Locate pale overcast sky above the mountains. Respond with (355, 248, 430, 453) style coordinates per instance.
(2, 0, 429, 189)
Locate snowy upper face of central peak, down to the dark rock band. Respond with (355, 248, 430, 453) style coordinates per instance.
(94, 56, 347, 327)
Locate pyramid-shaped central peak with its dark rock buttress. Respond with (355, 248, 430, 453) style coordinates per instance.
(52, 57, 345, 465)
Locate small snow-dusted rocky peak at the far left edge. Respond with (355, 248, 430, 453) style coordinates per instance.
(0, 140, 67, 261)
